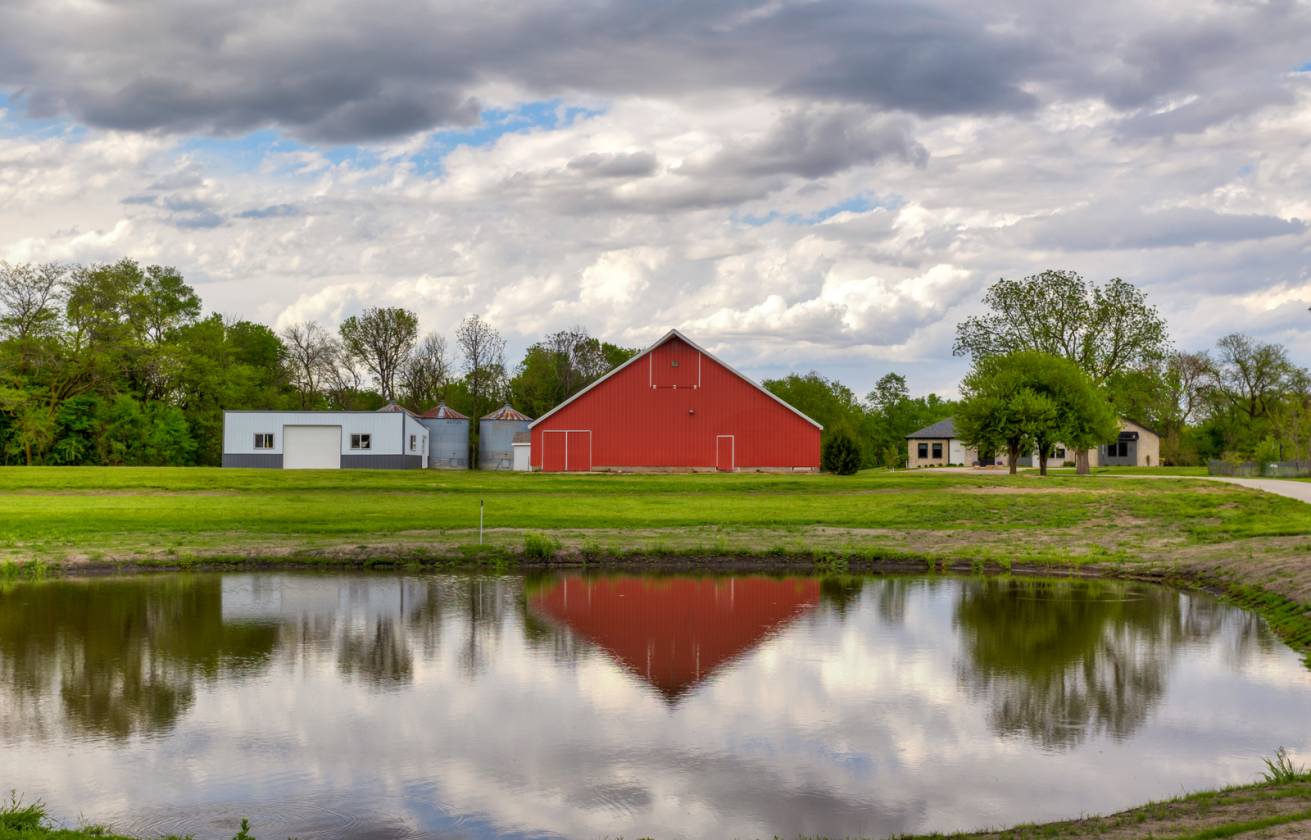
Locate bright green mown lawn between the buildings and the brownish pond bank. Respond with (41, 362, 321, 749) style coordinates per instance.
(0, 468, 1311, 562)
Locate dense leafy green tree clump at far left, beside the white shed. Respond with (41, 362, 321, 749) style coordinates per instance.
(0, 259, 300, 464)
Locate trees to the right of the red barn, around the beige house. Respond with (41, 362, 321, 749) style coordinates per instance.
(764, 270, 1311, 470)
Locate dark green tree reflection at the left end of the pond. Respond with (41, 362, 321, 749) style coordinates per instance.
(0, 575, 278, 738)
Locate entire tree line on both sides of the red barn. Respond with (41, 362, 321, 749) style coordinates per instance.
(0, 259, 1311, 472)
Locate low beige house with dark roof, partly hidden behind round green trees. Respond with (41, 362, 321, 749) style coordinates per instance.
(906, 417, 1160, 468)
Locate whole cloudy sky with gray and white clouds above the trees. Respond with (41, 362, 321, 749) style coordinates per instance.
(0, 0, 1311, 393)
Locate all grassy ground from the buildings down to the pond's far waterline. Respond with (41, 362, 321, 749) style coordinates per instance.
(0, 468, 1311, 649)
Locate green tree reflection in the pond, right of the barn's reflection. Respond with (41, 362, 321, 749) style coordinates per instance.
(954, 578, 1269, 748)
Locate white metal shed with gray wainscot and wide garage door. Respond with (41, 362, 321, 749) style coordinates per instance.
(223, 402, 429, 469)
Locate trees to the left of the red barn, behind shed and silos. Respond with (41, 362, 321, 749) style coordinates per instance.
(0, 259, 637, 465)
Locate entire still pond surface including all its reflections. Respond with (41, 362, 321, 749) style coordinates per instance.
(0, 574, 1311, 840)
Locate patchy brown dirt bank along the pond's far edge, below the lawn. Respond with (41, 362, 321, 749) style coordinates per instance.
(12, 528, 1311, 667)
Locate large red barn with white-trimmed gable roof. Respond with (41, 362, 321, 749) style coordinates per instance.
(530, 330, 822, 472)
